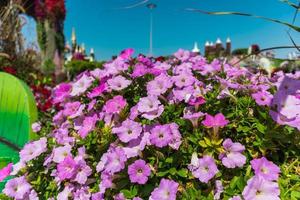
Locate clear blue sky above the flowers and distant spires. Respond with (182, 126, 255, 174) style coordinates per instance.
(22, 0, 300, 60)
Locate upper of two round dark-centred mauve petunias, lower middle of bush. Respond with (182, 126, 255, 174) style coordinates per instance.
(150, 125, 172, 148)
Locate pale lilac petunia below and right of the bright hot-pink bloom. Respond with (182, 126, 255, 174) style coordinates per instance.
(219, 139, 246, 168)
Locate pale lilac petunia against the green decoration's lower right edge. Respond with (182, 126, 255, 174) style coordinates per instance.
(20, 137, 47, 162)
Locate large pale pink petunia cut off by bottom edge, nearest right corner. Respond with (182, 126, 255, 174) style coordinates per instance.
(243, 176, 280, 200)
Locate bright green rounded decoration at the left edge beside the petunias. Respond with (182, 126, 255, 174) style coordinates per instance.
(0, 72, 37, 190)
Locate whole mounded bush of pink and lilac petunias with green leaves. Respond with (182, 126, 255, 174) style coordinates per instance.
(3, 49, 300, 200)
